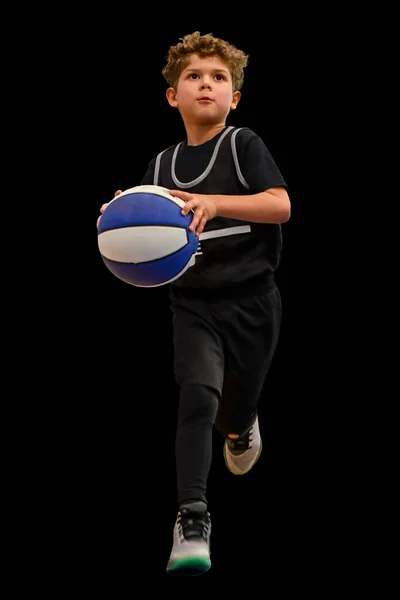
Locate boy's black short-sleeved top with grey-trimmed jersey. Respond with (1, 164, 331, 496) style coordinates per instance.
(141, 126, 287, 290)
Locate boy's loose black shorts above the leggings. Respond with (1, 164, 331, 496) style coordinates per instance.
(170, 281, 282, 431)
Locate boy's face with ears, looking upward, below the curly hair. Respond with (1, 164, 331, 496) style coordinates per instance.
(167, 54, 240, 125)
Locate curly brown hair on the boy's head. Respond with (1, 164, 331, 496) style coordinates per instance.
(162, 31, 249, 90)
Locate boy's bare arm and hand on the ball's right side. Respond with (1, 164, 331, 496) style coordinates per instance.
(169, 187, 290, 237)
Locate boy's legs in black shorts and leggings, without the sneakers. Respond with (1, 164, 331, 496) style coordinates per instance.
(172, 285, 281, 504)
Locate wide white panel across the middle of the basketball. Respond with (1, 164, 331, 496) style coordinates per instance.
(98, 225, 188, 263)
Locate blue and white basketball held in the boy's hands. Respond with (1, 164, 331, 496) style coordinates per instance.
(97, 185, 199, 287)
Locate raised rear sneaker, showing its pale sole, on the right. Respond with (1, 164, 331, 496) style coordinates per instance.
(224, 417, 262, 475)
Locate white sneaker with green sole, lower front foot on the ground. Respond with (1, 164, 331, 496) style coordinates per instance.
(167, 501, 211, 575)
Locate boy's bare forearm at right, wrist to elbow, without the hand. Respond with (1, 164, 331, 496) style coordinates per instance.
(212, 188, 290, 223)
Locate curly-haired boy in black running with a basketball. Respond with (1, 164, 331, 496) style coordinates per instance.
(99, 32, 290, 575)
